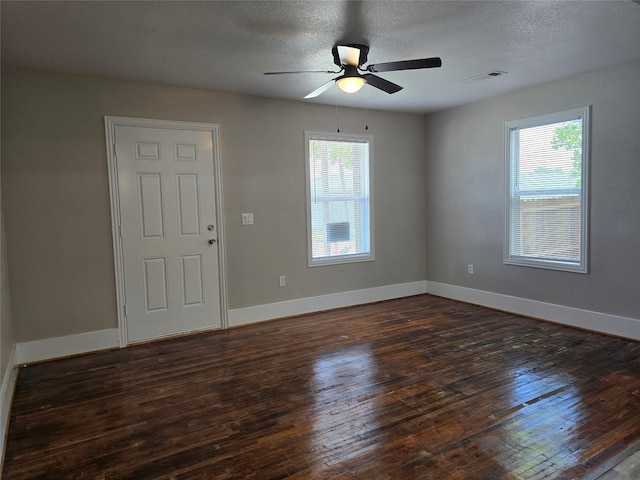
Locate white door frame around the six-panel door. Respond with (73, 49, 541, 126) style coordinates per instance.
(104, 116, 229, 348)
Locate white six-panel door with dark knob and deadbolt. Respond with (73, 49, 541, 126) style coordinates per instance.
(114, 125, 221, 342)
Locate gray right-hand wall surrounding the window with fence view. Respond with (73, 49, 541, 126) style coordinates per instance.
(425, 62, 640, 318)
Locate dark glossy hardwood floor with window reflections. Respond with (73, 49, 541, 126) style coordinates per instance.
(3, 295, 640, 480)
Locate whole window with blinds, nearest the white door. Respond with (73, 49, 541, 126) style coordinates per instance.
(305, 132, 374, 267)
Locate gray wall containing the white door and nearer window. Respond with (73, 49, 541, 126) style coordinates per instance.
(2, 69, 427, 341)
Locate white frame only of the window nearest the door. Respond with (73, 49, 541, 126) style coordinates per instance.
(304, 130, 375, 267)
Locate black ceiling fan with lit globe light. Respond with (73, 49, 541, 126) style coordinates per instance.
(265, 44, 442, 98)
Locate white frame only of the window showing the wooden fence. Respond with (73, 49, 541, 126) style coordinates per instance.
(504, 106, 591, 273)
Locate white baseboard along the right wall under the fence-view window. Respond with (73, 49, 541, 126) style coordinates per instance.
(426, 281, 640, 340)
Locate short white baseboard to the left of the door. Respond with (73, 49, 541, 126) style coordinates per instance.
(14, 328, 120, 365)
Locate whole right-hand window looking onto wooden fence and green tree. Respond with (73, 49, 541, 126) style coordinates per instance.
(505, 107, 589, 273)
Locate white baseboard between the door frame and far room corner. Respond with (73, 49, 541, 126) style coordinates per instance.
(229, 280, 426, 327)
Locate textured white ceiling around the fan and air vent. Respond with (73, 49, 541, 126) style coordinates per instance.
(0, 0, 640, 112)
